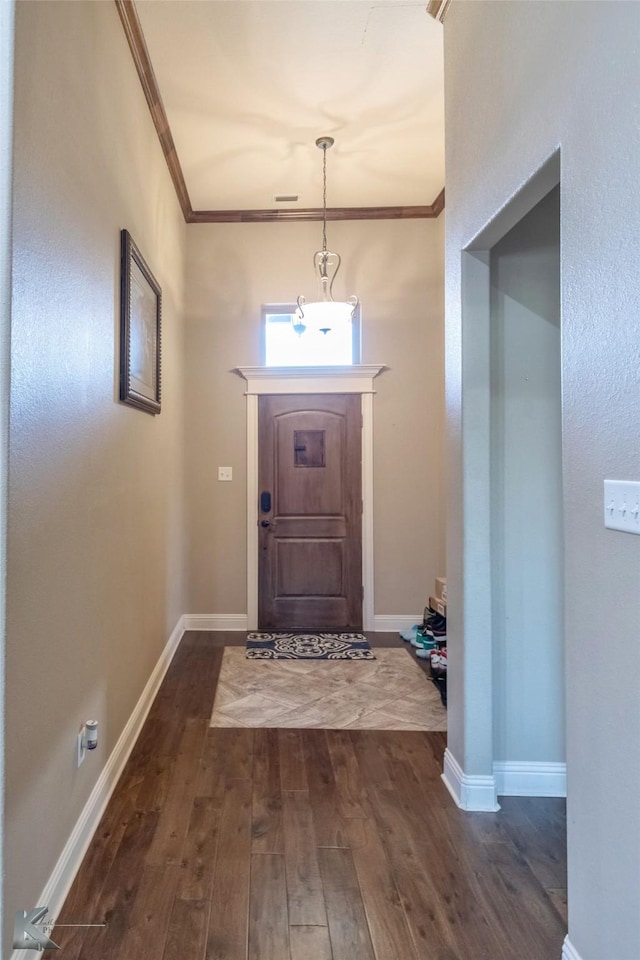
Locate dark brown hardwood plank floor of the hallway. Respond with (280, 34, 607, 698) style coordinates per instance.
(51, 633, 566, 960)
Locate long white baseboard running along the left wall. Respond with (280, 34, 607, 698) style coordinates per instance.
(11, 617, 184, 960)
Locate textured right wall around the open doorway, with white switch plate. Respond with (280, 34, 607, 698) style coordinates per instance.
(445, 0, 640, 960)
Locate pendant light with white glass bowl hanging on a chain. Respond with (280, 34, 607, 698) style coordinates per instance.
(291, 137, 359, 335)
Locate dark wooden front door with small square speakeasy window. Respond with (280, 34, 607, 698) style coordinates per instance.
(258, 394, 362, 630)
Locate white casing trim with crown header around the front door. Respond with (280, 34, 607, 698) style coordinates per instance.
(236, 364, 386, 630)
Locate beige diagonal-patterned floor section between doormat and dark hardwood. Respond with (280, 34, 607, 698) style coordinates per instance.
(211, 647, 447, 730)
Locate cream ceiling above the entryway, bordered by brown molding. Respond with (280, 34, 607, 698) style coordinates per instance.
(129, 0, 444, 211)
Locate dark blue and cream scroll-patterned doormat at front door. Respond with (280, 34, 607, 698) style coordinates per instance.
(247, 633, 375, 660)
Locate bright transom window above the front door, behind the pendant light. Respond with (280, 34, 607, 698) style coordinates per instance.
(262, 303, 360, 367)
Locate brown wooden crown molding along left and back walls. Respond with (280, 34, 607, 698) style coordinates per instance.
(114, 0, 449, 223)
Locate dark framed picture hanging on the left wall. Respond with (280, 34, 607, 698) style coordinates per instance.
(120, 230, 162, 414)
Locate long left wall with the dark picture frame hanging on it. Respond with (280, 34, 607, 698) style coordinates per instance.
(2, 2, 186, 944)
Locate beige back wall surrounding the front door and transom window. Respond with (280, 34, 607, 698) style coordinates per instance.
(185, 218, 445, 616)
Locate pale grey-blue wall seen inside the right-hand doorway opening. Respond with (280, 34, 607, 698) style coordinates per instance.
(490, 188, 565, 762)
